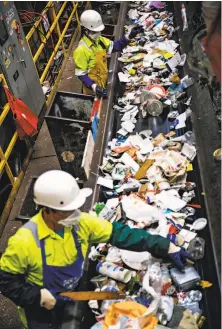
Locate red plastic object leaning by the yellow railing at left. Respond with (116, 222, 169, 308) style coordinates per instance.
(4, 88, 38, 139)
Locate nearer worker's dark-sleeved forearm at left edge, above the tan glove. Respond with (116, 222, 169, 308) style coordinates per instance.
(0, 270, 41, 308)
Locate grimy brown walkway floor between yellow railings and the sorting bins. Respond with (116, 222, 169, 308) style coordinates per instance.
(0, 38, 82, 329)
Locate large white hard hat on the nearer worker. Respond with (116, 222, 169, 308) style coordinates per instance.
(34, 170, 92, 211)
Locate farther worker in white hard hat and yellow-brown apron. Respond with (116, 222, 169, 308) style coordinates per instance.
(73, 10, 143, 97)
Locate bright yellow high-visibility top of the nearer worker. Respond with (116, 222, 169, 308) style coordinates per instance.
(0, 211, 112, 286)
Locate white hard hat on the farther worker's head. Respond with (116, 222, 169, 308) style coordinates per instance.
(80, 9, 105, 32)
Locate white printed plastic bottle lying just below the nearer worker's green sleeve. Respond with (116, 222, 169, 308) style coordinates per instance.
(96, 261, 134, 283)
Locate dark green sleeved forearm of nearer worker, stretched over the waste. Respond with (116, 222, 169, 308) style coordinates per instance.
(109, 223, 170, 258)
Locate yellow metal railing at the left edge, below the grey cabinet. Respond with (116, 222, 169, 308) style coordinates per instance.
(0, 74, 31, 235)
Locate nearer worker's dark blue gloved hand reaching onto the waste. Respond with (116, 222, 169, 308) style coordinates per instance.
(168, 242, 193, 272)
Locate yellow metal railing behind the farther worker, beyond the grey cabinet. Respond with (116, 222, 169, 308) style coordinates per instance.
(23, 1, 90, 105)
